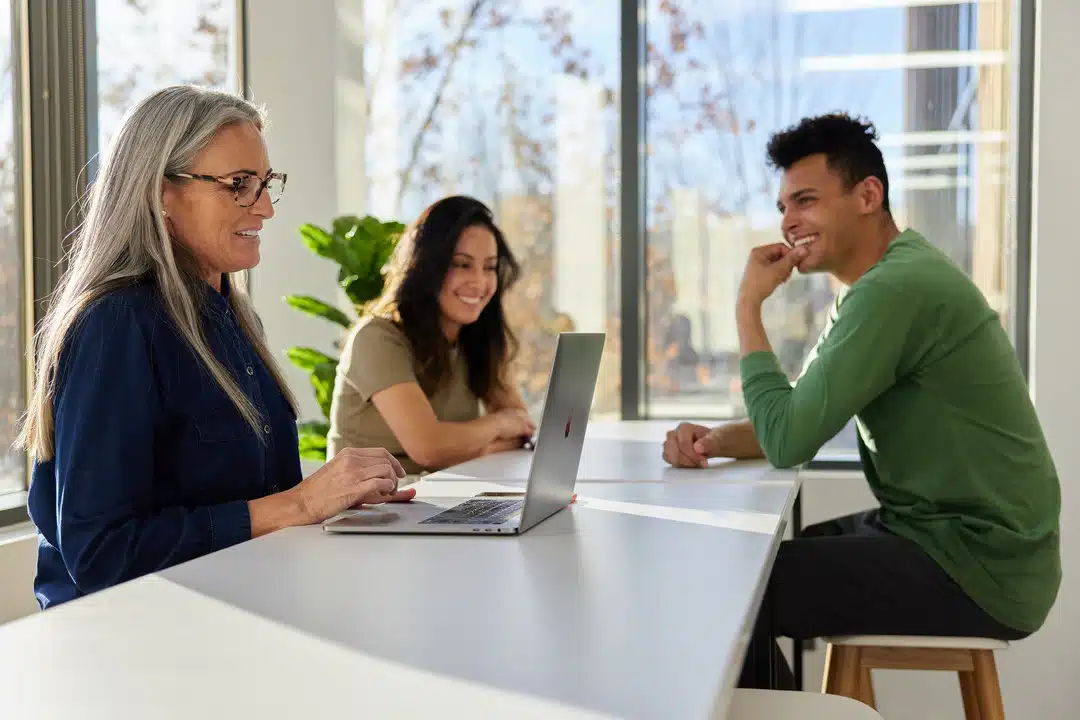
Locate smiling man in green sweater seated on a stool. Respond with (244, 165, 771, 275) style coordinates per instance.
(664, 114, 1062, 688)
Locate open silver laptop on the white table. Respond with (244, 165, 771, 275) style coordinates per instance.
(323, 332, 605, 534)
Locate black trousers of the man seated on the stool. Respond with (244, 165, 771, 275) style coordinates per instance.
(739, 511, 1028, 690)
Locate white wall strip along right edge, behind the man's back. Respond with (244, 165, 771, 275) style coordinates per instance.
(1000, 0, 1080, 718)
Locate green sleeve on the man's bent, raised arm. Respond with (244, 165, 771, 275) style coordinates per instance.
(740, 279, 918, 467)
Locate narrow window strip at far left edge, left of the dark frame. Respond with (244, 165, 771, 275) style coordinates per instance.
(0, 0, 26, 493)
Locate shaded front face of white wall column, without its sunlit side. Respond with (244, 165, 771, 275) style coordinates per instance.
(247, 0, 339, 427)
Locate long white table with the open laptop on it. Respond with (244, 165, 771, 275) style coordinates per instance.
(0, 418, 797, 718)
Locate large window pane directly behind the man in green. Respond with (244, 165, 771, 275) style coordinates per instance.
(644, 0, 1014, 446)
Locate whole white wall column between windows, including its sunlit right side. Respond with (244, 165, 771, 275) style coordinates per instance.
(246, 0, 373, 474)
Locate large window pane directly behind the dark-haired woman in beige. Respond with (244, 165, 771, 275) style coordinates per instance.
(351, 0, 633, 413)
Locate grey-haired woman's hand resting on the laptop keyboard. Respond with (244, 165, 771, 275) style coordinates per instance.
(286, 448, 416, 524)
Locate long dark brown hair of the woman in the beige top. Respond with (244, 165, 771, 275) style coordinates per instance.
(373, 195, 521, 400)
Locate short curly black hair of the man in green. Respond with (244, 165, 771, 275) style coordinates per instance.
(766, 112, 890, 213)
